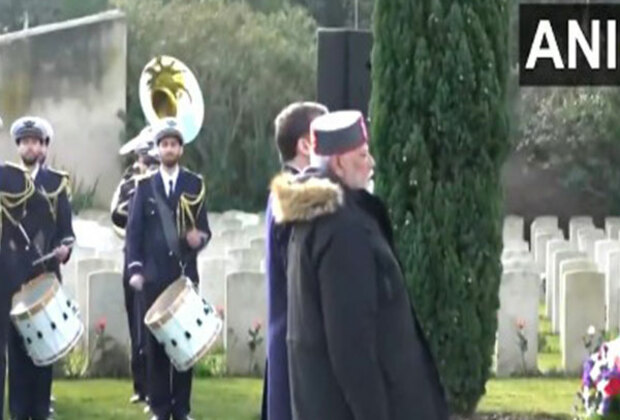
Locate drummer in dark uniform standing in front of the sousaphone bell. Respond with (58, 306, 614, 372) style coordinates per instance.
(127, 117, 211, 420)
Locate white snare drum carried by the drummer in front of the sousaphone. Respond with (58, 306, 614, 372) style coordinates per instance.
(144, 277, 223, 372)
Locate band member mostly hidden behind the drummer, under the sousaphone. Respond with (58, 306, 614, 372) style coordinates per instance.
(111, 130, 159, 404)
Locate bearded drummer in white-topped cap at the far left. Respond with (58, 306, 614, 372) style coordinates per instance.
(3, 117, 74, 420)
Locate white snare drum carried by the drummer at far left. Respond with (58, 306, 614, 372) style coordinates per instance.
(11, 273, 84, 366)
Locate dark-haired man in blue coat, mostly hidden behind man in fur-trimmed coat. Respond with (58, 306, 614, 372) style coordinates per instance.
(262, 102, 327, 420)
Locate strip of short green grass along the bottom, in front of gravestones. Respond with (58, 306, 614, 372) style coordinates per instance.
(46, 378, 579, 420)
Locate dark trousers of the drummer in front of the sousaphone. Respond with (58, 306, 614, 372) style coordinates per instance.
(144, 283, 192, 419)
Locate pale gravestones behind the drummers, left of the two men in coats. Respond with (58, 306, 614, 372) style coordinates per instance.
(50, 212, 266, 375)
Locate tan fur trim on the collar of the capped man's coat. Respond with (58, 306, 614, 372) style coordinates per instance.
(271, 172, 344, 223)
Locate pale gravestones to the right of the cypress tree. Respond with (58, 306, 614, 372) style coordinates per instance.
(496, 216, 620, 376)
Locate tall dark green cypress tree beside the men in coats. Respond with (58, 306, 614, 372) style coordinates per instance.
(370, 0, 509, 414)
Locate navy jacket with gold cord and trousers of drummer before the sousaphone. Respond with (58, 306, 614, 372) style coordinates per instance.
(127, 168, 211, 419)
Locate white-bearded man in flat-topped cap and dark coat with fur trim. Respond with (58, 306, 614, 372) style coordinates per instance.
(272, 111, 448, 420)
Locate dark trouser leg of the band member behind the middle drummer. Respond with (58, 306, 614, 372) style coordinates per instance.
(123, 275, 147, 399)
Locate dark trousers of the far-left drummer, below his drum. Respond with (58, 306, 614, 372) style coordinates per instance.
(8, 323, 52, 420)
